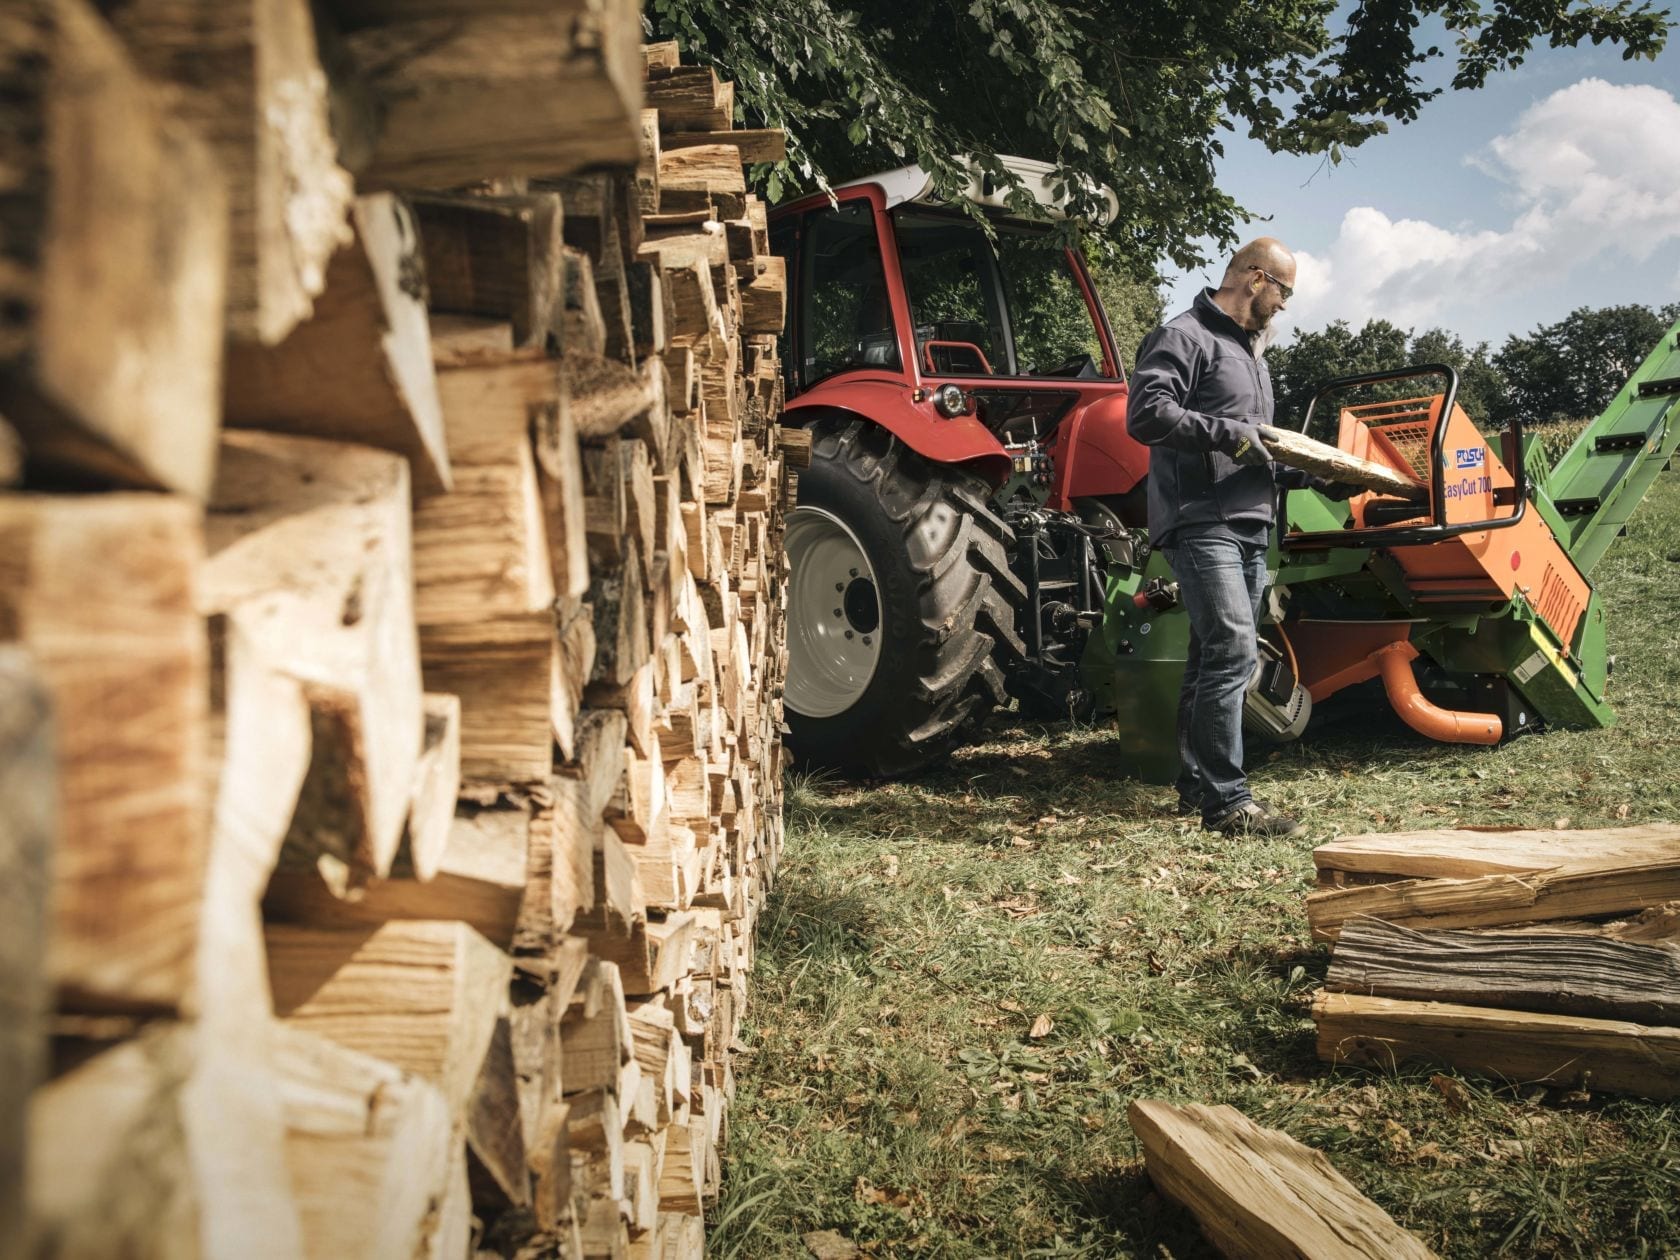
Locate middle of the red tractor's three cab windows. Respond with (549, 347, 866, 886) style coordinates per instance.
(894, 210, 1011, 376)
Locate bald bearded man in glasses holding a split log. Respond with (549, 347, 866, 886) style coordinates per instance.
(1126, 237, 1354, 835)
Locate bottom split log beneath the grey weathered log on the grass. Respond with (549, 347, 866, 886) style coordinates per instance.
(1312, 991, 1680, 1099)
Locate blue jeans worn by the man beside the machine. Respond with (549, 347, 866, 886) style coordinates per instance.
(1164, 528, 1268, 823)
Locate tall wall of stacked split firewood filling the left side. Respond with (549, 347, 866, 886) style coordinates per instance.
(0, 0, 808, 1260)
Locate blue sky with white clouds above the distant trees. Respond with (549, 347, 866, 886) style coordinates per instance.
(1168, 32, 1680, 349)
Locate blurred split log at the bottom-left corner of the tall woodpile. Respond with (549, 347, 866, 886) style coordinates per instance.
(24, 1021, 198, 1260)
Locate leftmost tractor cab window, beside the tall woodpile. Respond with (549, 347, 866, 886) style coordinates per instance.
(798, 202, 900, 388)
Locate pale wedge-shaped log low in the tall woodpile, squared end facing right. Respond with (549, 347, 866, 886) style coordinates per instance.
(267, 919, 509, 1114)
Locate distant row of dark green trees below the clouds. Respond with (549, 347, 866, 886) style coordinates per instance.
(1267, 302, 1680, 430)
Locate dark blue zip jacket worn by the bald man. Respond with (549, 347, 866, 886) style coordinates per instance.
(1126, 289, 1315, 546)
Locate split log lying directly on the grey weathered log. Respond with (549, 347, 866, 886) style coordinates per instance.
(1307, 855, 1680, 941)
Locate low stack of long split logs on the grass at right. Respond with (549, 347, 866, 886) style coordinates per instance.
(1307, 825, 1680, 1099)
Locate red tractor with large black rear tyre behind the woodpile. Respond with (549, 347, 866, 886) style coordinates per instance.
(771, 158, 1149, 774)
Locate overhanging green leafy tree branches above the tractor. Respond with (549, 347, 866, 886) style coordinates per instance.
(647, 0, 1672, 269)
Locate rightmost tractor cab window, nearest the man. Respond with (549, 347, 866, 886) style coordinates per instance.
(998, 232, 1102, 376)
